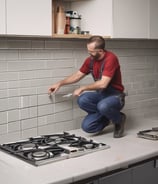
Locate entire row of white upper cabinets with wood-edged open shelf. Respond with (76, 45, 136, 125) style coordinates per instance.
(0, 0, 158, 39)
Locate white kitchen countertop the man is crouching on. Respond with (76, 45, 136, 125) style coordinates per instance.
(0, 118, 158, 184)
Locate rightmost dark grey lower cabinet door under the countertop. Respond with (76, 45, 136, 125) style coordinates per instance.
(132, 161, 158, 184)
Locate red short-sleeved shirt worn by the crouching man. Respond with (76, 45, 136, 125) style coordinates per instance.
(80, 51, 124, 91)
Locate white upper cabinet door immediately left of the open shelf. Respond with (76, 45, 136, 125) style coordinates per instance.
(6, 0, 52, 36)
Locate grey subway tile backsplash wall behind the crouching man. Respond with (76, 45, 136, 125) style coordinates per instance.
(0, 38, 158, 142)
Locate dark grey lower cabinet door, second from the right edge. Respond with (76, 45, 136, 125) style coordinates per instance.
(99, 169, 131, 184)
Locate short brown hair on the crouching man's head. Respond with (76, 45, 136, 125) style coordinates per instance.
(87, 36, 105, 50)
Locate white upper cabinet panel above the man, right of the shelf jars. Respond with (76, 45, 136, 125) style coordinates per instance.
(71, 0, 112, 36)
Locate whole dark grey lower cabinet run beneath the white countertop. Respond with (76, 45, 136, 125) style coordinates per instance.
(74, 158, 158, 184)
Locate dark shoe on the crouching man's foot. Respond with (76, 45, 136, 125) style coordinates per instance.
(114, 112, 126, 138)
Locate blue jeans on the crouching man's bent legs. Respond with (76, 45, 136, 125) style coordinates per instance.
(78, 88, 125, 133)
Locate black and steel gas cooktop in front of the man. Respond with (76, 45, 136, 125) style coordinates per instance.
(0, 132, 110, 166)
